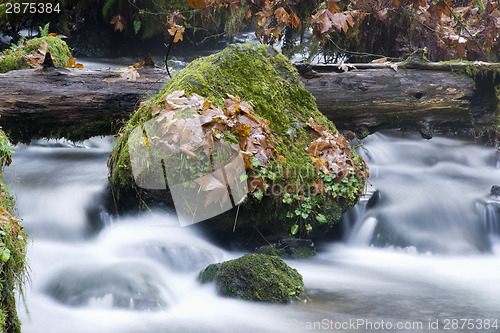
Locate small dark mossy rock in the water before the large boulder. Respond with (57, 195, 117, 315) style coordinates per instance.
(199, 254, 304, 303)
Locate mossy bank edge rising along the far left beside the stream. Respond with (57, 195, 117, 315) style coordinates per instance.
(0, 130, 27, 333)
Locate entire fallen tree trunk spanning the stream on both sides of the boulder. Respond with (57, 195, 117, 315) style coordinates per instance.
(0, 61, 500, 142)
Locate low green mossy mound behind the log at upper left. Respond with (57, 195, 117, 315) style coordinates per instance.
(0, 36, 71, 73)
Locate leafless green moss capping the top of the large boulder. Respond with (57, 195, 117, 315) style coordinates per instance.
(112, 45, 342, 189)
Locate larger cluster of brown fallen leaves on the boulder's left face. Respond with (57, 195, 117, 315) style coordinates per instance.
(149, 90, 278, 200)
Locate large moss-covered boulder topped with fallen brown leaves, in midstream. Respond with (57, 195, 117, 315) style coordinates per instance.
(108, 45, 368, 246)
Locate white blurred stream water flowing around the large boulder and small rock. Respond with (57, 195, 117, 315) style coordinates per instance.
(5, 132, 500, 333)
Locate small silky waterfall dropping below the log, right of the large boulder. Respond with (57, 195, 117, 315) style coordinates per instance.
(344, 133, 500, 254)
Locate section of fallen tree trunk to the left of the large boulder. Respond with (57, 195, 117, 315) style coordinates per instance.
(0, 66, 168, 142)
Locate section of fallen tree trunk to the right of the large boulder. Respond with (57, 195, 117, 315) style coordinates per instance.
(296, 61, 500, 138)
